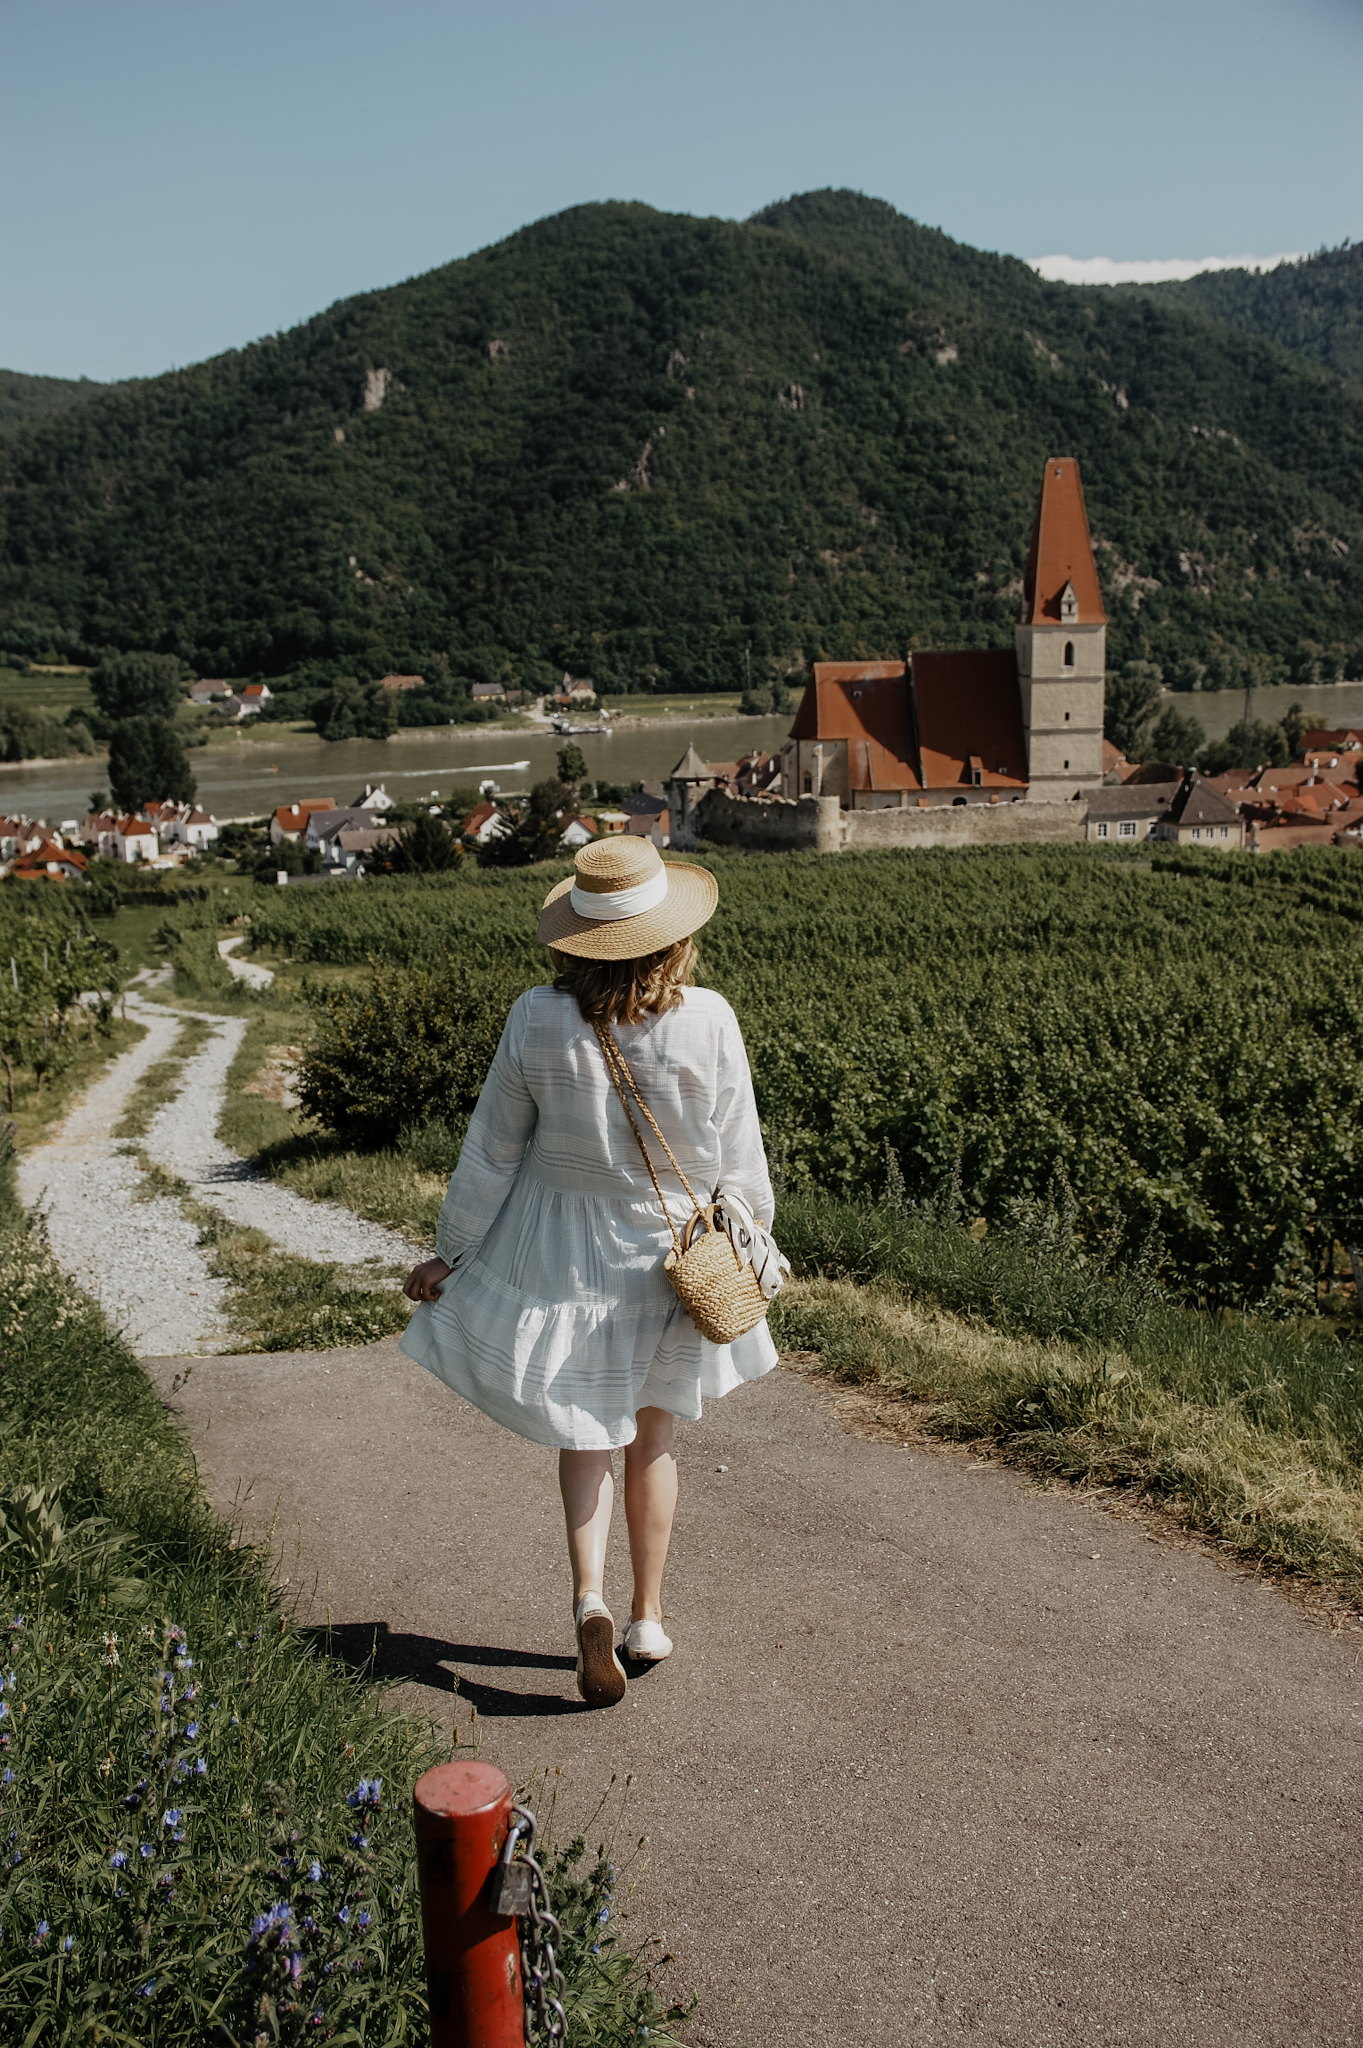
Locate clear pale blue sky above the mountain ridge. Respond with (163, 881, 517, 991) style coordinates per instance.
(0, 0, 1363, 377)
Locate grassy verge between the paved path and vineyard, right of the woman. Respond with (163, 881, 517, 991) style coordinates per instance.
(772, 1192, 1363, 1597)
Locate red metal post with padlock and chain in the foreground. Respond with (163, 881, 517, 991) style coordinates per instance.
(413, 1763, 526, 2048)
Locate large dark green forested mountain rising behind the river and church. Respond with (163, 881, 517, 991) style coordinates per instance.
(0, 193, 1363, 690)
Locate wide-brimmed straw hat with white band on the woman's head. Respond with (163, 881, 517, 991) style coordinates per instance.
(538, 834, 718, 961)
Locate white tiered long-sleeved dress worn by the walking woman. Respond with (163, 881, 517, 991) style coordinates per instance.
(401, 987, 776, 1450)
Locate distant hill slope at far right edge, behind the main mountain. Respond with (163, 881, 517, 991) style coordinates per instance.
(1119, 242, 1363, 383)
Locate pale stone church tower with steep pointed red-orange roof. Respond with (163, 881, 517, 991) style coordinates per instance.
(1017, 455, 1107, 803)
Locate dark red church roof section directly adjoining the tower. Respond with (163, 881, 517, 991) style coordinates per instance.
(913, 647, 1027, 788)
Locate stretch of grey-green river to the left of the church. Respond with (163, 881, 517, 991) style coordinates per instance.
(0, 717, 790, 823)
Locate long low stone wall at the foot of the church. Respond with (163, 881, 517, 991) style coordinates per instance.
(696, 788, 1089, 854)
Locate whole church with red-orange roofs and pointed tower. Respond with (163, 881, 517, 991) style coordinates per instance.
(782, 457, 1107, 811)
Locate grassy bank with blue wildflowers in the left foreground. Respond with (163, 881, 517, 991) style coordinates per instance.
(0, 1163, 671, 2048)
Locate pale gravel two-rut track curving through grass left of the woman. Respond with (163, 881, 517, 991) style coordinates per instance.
(18, 978, 424, 1358)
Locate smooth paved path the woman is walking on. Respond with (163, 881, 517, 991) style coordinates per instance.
(151, 1341, 1363, 2048)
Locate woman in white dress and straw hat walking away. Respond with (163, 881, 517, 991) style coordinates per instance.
(403, 838, 776, 1706)
